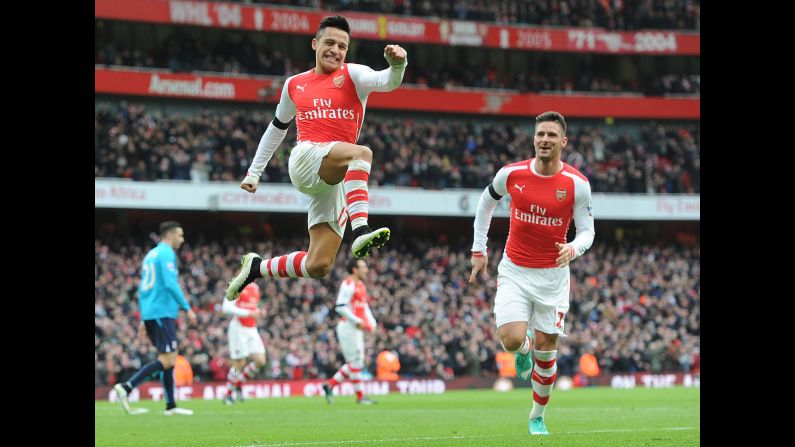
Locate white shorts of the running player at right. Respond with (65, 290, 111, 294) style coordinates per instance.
(494, 254, 571, 337)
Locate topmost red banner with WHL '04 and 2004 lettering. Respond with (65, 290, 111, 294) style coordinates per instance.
(94, 0, 701, 56)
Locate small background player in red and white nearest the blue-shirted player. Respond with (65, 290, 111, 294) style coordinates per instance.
(223, 283, 265, 405)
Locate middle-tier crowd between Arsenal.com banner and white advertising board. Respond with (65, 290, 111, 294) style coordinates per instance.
(94, 102, 700, 194)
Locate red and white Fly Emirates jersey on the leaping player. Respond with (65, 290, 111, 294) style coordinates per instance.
(276, 63, 406, 143)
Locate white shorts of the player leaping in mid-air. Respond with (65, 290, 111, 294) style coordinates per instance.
(288, 141, 348, 237)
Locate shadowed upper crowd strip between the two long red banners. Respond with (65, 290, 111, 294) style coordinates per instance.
(94, 37, 701, 96)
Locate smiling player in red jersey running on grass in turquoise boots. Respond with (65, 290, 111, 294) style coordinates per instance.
(469, 112, 594, 435)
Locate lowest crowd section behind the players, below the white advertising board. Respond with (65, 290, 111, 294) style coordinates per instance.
(94, 234, 700, 386)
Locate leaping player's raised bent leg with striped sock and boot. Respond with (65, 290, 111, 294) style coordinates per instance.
(318, 143, 390, 258)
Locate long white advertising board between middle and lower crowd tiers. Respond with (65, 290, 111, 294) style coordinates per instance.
(94, 179, 701, 220)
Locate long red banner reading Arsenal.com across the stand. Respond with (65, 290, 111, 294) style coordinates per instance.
(94, 66, 701, 119)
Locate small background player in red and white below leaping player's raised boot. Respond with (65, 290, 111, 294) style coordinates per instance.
(323, 258, 376, 405)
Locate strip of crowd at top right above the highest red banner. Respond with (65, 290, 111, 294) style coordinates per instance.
(227, 0, 701, 30)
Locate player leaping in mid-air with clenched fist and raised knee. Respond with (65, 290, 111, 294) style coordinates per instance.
(226, 16, 407, 300)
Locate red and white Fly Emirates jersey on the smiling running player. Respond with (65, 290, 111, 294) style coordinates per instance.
(483, 158, 594, 268)
